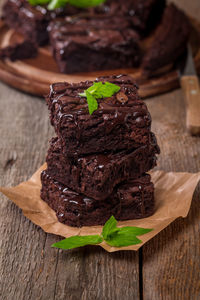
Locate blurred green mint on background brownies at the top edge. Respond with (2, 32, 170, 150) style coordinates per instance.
(28, 0, 106, 10)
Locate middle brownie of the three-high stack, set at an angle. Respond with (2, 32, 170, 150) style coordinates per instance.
(46, 134, 159, 200)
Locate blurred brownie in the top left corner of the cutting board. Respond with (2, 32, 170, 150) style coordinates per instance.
(3, 0, 80, 45)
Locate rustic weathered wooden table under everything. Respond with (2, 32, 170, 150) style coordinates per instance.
(0, 0, 200, 300)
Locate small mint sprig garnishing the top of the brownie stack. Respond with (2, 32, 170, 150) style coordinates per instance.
(79, 81, 120, 115)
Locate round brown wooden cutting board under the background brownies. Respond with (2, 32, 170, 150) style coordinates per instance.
(0, 19, 200, 98)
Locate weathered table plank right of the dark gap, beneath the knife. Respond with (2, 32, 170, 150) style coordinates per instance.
(143, 91, 200, 300)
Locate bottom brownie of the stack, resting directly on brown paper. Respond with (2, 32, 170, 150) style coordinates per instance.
(41, 170, 154, 227)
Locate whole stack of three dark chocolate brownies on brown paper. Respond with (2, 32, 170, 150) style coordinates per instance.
(41, 75, 159, 227)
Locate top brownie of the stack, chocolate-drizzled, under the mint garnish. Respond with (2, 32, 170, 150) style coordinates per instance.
(46, 75, 151, 156)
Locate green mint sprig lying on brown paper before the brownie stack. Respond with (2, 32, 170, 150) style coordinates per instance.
(51, 216, 153, 250)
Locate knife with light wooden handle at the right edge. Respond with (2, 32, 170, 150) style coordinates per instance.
(178, 45, 200, 135)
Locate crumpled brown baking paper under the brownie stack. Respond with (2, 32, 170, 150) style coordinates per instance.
(0, 164, 200, 252)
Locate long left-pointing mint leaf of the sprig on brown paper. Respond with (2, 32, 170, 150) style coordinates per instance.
(51, 235, 103, 250)
